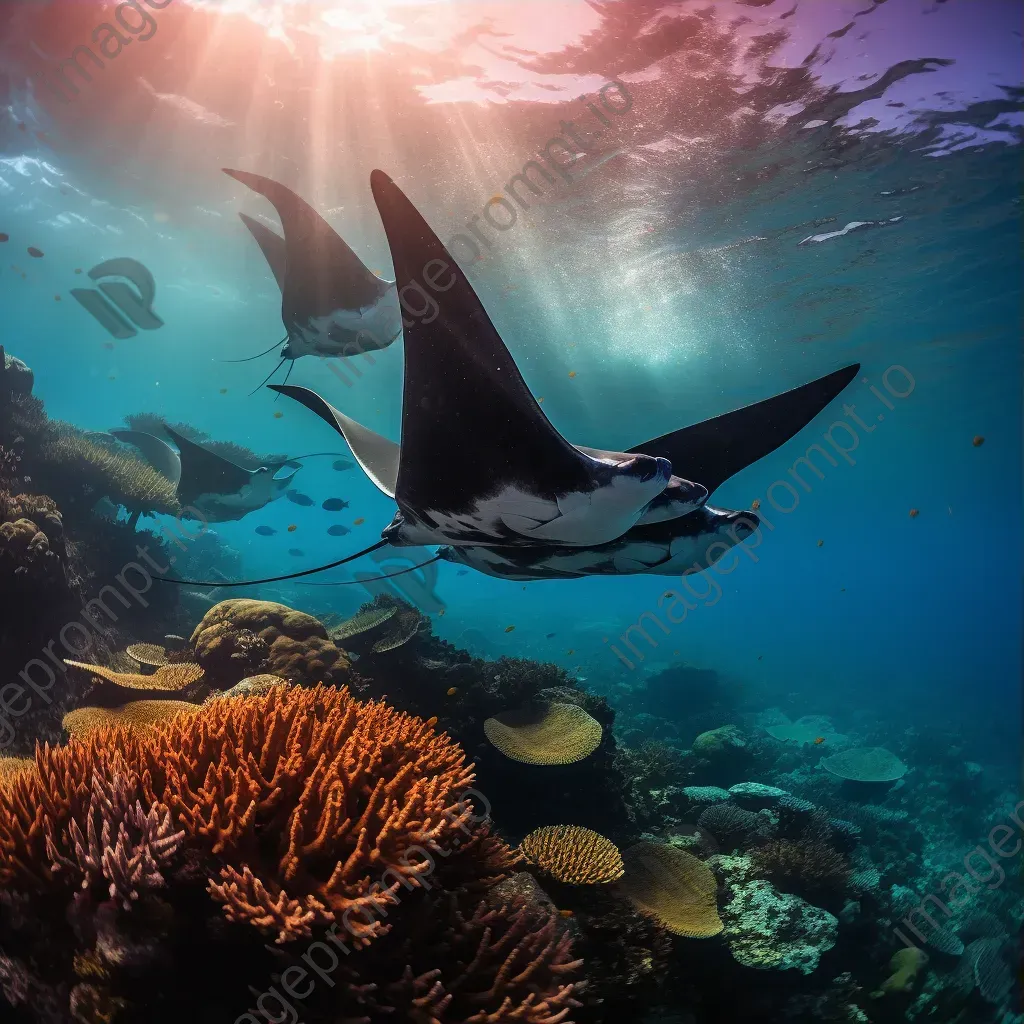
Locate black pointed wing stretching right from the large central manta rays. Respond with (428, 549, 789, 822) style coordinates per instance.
(630, 362, 860, 494)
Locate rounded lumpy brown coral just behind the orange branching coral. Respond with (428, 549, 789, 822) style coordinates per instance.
(191, 599, 349, 688)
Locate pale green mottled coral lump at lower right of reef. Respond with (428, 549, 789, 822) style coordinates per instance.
(722, 879, 839, 974)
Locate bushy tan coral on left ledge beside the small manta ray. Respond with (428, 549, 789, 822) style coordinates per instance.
(36, 421, 181, 513)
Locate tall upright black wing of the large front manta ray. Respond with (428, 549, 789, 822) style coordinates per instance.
(370, 171, 614, 528)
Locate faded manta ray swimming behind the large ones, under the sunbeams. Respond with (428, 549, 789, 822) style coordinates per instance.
(224, 167, 402, 390)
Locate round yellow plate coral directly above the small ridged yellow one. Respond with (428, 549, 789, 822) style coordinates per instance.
(483, 701, 602, 765)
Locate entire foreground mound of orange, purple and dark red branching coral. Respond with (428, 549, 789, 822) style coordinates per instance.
(0, 685, 582, 1024)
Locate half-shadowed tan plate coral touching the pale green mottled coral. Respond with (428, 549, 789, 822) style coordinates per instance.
(620, 843, 723, 939)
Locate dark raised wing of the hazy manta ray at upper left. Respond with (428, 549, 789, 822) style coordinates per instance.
(224, 167, 388, 315)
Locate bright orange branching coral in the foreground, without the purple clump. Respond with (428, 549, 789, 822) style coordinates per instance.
(0, 686, 516, 946)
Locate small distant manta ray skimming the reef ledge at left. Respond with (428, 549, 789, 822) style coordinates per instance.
(110, 425, 338, 522)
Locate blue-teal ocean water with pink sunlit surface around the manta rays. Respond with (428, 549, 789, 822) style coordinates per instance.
(0, 0, 1024, 1024)
